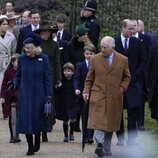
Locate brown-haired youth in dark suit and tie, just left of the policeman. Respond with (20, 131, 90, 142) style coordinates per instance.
(54, 13, 71, 65)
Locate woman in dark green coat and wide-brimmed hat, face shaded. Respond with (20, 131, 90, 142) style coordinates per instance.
(34, 22, 62, 142)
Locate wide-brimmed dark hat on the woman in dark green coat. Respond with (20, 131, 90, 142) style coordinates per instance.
(33, 21, 58, 33)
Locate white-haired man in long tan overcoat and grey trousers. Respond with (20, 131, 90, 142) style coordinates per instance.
(83, 36, 131, 157)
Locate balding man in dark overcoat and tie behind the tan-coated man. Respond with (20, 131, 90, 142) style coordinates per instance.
(115, 19, 146, 145)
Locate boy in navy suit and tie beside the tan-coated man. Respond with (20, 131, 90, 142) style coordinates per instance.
(74, 44, 96, 144)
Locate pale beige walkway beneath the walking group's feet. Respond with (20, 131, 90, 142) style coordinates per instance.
(0, 107, 158, 158)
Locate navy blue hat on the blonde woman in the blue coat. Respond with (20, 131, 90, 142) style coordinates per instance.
(23, 32, 42, 46)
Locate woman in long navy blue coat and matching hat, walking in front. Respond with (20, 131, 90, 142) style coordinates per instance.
(14, 33, 52, 155)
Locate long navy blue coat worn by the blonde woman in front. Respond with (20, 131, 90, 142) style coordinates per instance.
(14, 54, 52, 134)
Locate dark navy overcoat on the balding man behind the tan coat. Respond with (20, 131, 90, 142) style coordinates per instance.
(115, 36, 147, 108)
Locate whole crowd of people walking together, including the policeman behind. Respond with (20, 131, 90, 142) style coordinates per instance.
(0, 0, 158, 157)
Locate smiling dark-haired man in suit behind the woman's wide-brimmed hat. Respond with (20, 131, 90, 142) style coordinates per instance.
(16, 9, 41, 54)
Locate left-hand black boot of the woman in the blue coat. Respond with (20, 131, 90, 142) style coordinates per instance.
(26, 134, 34, 155)
